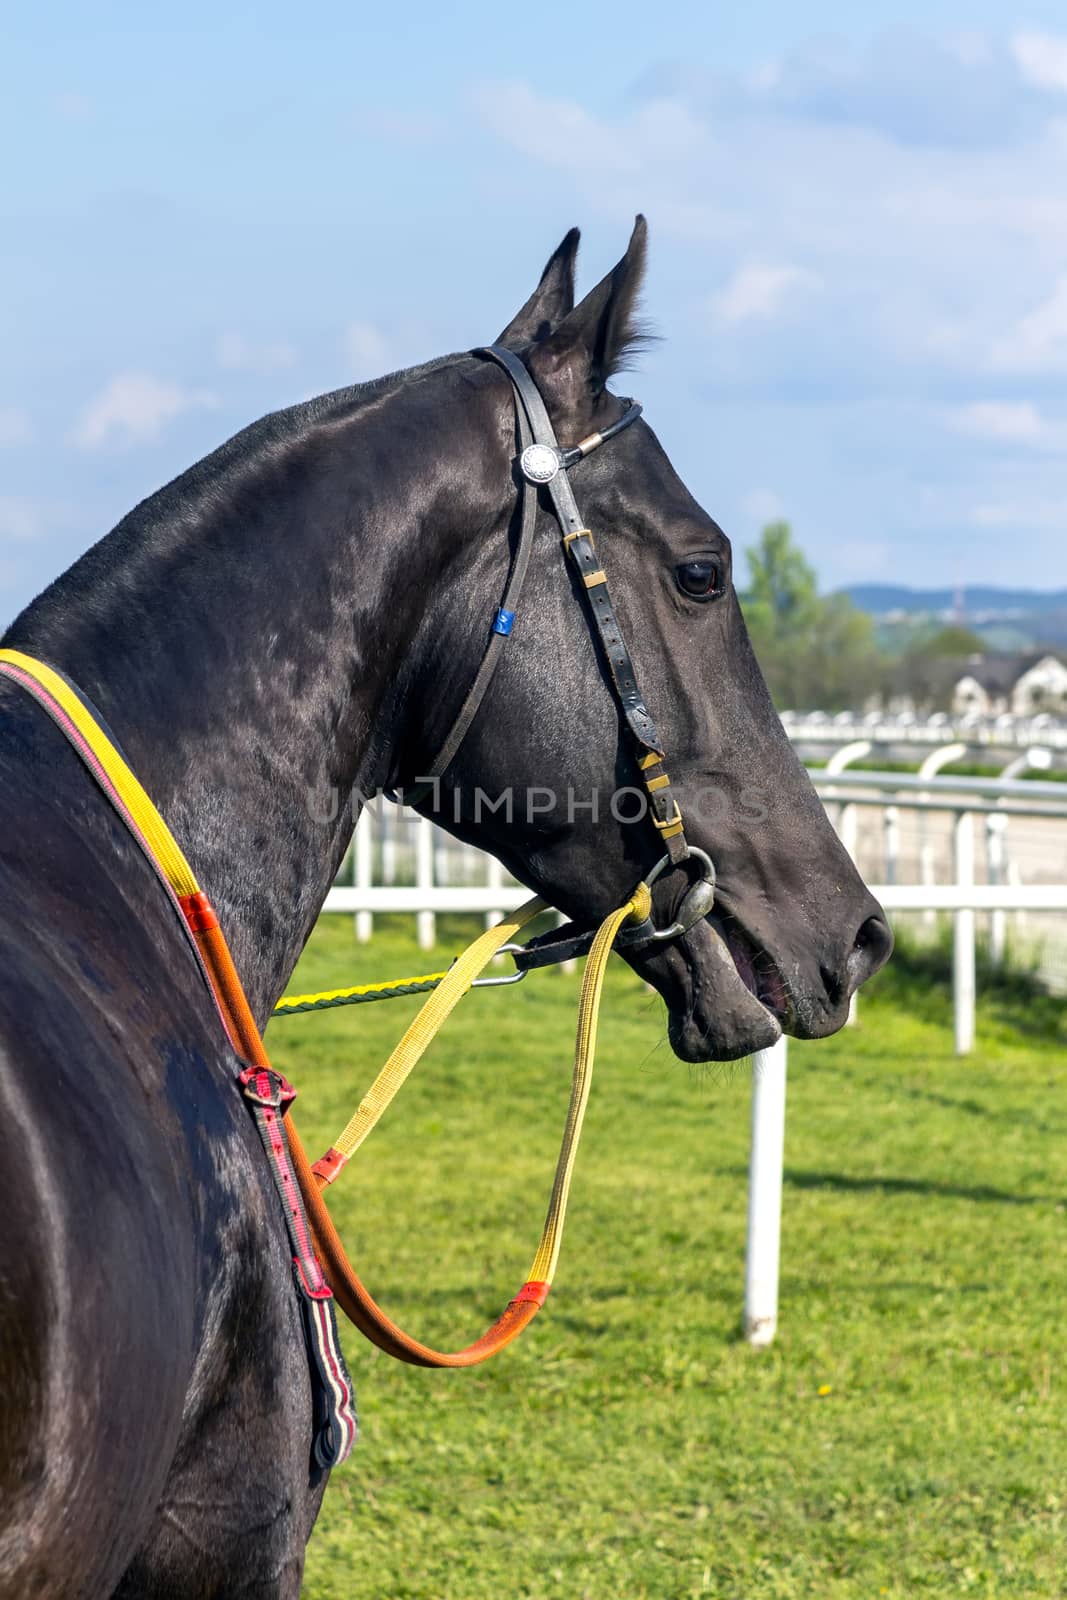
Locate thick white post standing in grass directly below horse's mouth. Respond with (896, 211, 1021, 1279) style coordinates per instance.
(744, 1034, 785, 1349)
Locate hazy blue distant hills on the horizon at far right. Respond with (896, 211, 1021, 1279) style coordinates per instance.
(841, 584, 1067, 650)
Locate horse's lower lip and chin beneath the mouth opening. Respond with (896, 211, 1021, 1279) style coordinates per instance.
(630, 922, 782, 1061)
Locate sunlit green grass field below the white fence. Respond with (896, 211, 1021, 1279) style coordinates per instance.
(269, 917, 1067, 1600)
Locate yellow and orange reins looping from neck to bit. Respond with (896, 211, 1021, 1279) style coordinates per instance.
(0, 650, 651, 1366)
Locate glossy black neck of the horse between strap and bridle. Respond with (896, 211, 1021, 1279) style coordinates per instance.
(5, 366, 506, 1022)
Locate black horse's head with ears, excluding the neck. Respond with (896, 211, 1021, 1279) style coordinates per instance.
(399, 218, 893, 1061)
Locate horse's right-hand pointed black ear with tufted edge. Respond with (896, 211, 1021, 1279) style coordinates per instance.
(530, 216, 649, 422)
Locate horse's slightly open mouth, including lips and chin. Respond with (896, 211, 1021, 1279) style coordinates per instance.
(627, 906, 793, 1062)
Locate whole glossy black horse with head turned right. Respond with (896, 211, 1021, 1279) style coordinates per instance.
(0, 219, 891, 1600)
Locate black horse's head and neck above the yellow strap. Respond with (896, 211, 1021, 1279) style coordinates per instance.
(8, 218, 891, 1061)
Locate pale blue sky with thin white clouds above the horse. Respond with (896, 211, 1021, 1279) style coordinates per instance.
(0, 0, 1067, 621)
